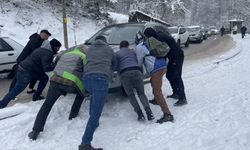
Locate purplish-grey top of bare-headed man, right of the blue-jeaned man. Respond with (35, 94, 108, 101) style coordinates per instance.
(116, 48, 139, 72)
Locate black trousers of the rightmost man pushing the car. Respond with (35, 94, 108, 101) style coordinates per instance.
(166, 55, 186, 99)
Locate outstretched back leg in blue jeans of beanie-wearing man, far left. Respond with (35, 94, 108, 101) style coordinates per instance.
(0, 68, 30, 108)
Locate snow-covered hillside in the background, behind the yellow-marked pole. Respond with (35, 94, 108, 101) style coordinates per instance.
(0, 0, 128, 49)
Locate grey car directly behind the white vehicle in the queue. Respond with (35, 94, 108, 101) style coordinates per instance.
(187, 26, 203, 43)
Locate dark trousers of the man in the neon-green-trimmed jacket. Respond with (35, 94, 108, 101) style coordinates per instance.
(33, 81, 84, 131)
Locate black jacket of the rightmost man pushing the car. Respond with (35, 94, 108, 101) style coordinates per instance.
(157, 32, 184, 62)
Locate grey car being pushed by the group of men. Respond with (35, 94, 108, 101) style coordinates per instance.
(85, 22, 168, 91)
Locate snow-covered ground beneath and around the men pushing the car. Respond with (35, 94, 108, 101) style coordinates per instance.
(0, 35, 250, 150)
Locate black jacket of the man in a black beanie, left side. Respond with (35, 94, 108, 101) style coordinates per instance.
(20, 40, 55, 74)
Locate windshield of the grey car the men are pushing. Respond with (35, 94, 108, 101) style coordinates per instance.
(86, 24, 144, 45)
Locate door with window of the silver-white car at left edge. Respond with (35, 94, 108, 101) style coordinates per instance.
(0, 38, 16, 72)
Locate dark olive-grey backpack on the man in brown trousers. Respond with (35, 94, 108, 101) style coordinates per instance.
(145, 37, 170, 57)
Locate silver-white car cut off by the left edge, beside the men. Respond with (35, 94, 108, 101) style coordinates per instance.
(0, 37, 24, 77)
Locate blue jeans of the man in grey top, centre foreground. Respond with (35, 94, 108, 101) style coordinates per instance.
(82, 74, 109, 145)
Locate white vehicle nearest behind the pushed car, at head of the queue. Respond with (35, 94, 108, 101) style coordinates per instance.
(168, 26, 189, 47)
